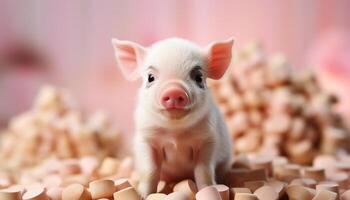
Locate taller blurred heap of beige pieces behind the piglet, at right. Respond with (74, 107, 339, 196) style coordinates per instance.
(211, 43, 349, 164)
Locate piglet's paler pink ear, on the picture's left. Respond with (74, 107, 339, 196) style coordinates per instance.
(112, 39, 146, 80)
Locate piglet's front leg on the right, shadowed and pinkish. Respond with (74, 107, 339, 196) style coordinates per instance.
(194, 143, 215, 189)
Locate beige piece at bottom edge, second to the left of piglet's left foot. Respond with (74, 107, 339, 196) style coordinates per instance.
(89, 180, 115, 199)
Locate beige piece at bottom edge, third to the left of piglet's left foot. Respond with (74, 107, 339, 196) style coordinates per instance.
(62, 183, 91, 200)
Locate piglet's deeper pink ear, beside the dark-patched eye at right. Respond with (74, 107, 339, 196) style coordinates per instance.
(206, 38, 234, 79)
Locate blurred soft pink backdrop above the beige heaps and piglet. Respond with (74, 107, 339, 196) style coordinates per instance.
(0, 0, 350, 135)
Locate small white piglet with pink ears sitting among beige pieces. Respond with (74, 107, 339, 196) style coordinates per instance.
(112, 38, 233, 197)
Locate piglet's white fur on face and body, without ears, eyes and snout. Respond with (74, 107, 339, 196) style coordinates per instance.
(116, 38, 232, 196)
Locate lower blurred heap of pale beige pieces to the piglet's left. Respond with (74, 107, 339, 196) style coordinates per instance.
(0, 86, 121, 169)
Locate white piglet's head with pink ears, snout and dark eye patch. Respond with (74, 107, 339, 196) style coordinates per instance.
(112, 38, 233, 121)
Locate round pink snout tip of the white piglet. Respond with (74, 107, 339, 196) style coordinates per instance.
(160, 85, 189, 109)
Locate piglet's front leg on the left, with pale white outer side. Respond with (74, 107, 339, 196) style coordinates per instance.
(134, 140, 160, 198)
